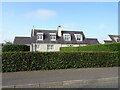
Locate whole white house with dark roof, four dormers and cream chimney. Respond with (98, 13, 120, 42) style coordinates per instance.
(14, 26, 99, 51)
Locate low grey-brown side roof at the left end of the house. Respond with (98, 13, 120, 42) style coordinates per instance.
(14, 37, 31, 44)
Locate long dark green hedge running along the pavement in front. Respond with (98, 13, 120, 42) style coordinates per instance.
(2, 52, 119, 72)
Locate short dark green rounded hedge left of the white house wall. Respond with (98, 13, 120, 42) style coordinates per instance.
(2, 44, 30, 52)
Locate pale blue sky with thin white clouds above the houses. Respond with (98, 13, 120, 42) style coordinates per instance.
(2, 2, 118, 43)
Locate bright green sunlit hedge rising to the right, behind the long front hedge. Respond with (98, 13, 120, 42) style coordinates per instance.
(60, 43, 120, 51)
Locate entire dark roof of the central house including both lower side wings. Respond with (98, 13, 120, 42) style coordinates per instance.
(14, 29, 99, 44)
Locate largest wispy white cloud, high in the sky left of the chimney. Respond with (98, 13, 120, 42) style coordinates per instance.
(26, 10, 56, 19)
